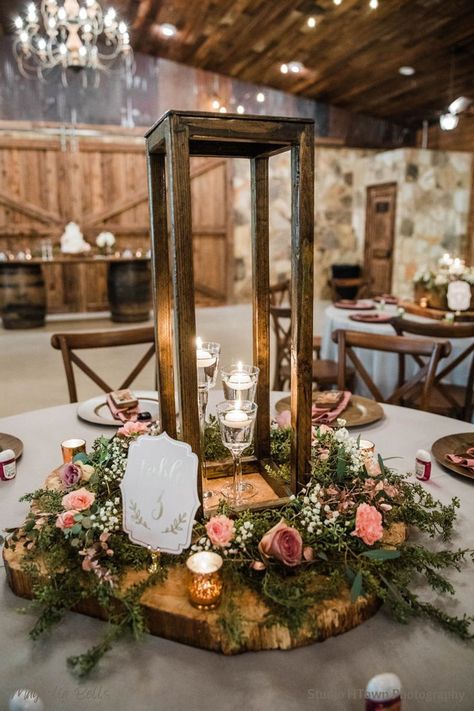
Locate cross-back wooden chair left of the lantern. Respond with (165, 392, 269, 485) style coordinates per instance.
(51, 326, 155, 402)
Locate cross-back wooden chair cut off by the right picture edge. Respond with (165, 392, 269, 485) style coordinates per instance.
(391, 316, 474, 422)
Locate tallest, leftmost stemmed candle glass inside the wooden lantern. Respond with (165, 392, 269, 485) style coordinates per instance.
(196, 338, 221, 499)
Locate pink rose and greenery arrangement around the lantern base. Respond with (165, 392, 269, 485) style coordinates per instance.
(4, 420, 473, 675)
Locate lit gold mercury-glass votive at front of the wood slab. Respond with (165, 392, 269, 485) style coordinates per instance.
(186, 551, 223, 610)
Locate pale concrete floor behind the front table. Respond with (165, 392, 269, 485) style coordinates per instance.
(0, 303, 326, 417)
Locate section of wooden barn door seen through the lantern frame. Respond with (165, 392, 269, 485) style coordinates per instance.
(191, 158, 234, 305)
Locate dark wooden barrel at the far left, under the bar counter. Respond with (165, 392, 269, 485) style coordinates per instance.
(0, 262, 46, 329)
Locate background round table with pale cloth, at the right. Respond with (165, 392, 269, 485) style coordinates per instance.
(321, 304, 471, 397)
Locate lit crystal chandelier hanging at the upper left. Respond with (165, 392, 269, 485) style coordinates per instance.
(14, 0, 133, 85)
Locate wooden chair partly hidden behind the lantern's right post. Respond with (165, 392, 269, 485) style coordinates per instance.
(270, 306, 354, 390)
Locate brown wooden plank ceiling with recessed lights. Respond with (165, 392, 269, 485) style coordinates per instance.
(0, 0, 474, 124)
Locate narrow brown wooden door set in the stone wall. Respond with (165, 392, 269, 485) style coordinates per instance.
(364, 183, 397, 295)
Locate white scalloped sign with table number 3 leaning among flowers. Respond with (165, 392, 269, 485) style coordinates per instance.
(120, 432, 200, 554)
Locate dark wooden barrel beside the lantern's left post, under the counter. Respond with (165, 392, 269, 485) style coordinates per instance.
(108, 259, 151, 323)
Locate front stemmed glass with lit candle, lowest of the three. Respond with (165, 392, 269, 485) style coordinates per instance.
(217, 400, 257, 506)
